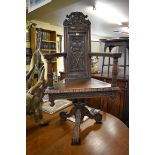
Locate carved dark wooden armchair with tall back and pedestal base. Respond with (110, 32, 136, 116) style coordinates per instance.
(44, 12, 121, 145)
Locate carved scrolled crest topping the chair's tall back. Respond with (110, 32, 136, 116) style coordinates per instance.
(63, 12, 91, 26)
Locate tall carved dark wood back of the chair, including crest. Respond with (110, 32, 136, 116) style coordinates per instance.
(63, 12, 91, 80)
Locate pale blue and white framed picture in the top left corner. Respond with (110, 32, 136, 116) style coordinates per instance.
(28, 0, 52, 13)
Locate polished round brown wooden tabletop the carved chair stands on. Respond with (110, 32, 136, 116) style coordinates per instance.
(26, 108, 129, 155)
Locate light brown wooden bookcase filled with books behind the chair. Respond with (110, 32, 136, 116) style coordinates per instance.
(30, 27, 58, 81)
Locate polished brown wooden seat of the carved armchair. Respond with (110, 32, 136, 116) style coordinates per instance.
(46, 78, 119, 98)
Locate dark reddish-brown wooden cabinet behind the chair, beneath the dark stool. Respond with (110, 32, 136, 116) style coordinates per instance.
(60, 72, 129, 125)
